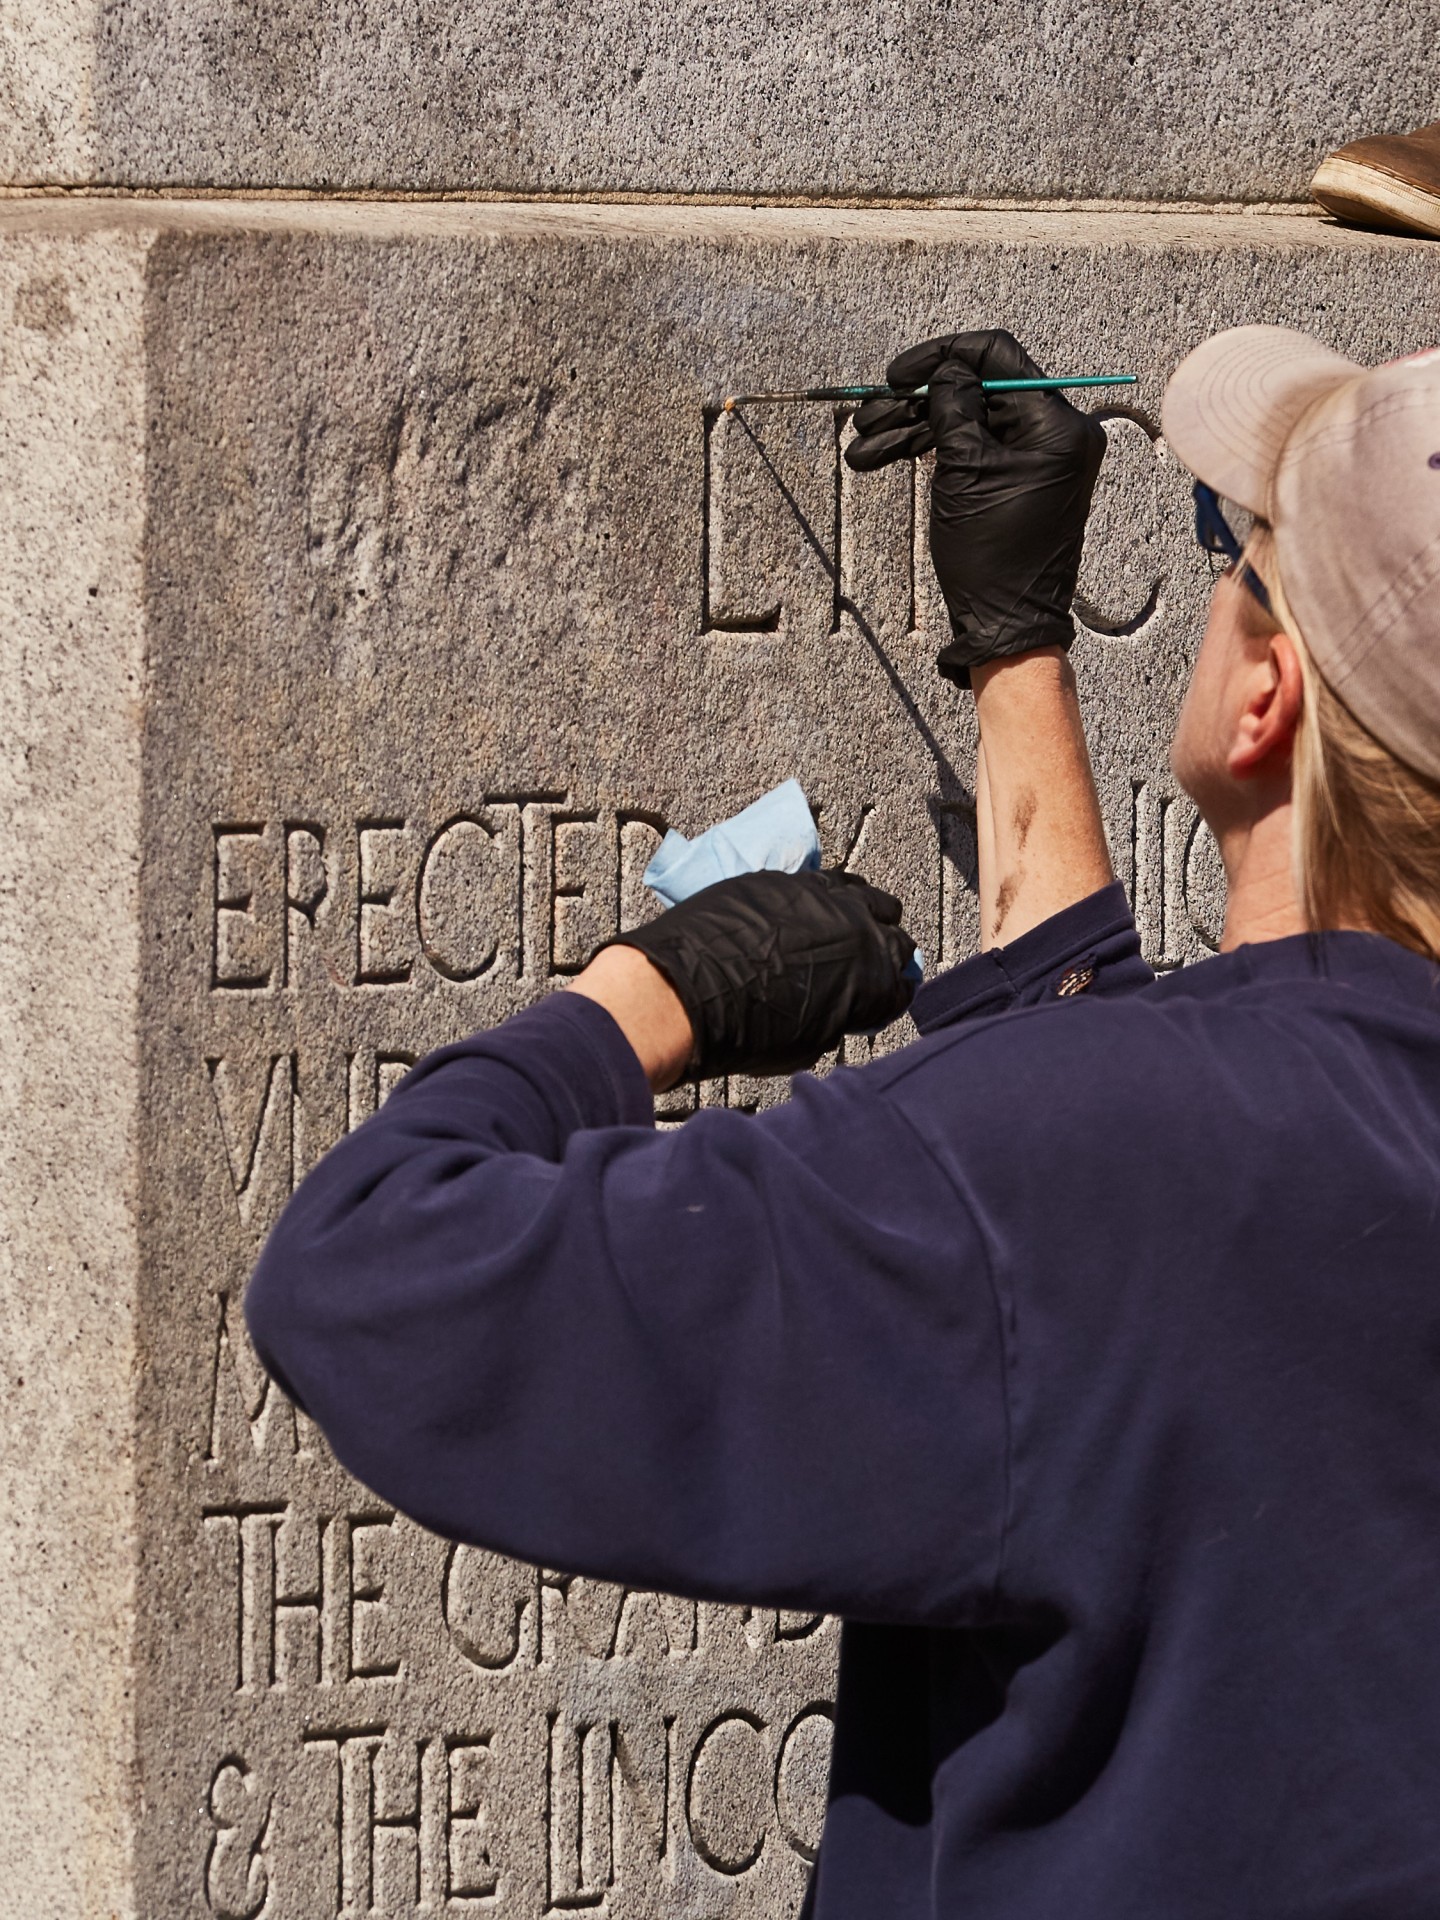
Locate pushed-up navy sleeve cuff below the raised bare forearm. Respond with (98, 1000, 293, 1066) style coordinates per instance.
(910, 881, 1156, 1033)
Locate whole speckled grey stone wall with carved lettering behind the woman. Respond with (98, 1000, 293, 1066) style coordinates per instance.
(0, 22, 1440, 1920)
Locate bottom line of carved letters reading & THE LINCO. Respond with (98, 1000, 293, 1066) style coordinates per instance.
(261, 1701, 831, 1920)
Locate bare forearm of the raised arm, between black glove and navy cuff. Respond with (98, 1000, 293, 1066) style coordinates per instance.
(970, 647, 1114, 947)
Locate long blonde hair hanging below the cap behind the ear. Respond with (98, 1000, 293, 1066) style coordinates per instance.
(1244, 524, 1440, 960)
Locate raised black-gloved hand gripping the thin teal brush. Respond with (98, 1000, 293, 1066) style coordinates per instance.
(845, 330, 1106, 687)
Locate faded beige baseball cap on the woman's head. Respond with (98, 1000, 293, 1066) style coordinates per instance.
(1162, 326, 1440, 780)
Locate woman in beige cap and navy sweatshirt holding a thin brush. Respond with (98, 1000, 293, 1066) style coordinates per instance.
(248, 328, 1440, 1920)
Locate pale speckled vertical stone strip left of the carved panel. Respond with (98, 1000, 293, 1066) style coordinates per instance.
(0, 221, 146, 1920)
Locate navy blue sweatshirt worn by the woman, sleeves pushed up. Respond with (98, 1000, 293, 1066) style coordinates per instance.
(248, 889, 1440, 1920)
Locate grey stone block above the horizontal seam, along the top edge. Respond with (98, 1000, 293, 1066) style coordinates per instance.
(0, 0, 1440, 202)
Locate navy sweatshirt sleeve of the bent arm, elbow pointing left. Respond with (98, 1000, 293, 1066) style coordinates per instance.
(246, 993, 1006, 1624)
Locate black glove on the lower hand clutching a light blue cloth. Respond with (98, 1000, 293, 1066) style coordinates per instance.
(607, 870, 916, 1079)
